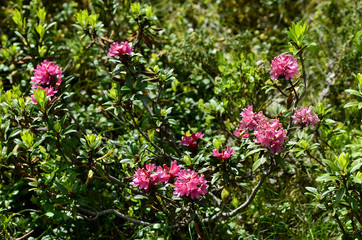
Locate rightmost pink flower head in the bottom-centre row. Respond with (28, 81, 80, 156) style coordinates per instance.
(173, 169, 207, 199)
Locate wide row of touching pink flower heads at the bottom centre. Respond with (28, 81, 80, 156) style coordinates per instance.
(133, 161, 207, 199)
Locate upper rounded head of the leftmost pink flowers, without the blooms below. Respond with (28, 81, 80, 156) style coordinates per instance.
(31, 60, 63, 87)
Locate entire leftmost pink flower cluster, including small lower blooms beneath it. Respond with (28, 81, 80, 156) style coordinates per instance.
(31, 60, 63, 104)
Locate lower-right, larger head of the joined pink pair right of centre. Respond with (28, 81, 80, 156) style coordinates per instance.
(254, 119, 288, 154)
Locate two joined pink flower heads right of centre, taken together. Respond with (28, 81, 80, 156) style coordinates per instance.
(234, 106, 287, 154)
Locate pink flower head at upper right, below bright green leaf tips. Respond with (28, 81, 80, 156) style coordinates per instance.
(270, 53, 300, 80)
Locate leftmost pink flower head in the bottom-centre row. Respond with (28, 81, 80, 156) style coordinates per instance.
(133, 163, 169, 191)
